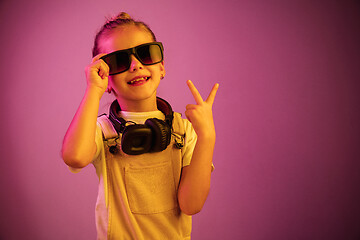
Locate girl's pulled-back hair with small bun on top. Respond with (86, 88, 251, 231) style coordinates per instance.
(92, 12, 156, 57)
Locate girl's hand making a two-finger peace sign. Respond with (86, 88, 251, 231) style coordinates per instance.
(185, 80, 219, 140)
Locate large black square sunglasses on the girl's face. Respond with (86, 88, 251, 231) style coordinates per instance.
(100, 42, 164, 75)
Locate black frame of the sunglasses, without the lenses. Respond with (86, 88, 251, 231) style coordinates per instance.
(100, 42, 164, 75)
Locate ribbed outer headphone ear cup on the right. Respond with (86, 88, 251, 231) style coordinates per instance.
(145, 118, 171, 152)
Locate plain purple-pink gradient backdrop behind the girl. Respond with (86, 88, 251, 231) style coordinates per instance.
(0, 0, 360, 240)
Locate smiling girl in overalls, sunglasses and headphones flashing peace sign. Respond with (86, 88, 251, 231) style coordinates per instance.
(62, 13, 218, 239)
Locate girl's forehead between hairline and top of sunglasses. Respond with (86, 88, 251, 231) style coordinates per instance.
(100, 25, 153, 53)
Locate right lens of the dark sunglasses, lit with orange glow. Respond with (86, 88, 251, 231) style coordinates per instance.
(136, 44, 163, 65)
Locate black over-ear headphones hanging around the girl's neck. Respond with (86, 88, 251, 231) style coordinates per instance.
(109, 97, 174, 155)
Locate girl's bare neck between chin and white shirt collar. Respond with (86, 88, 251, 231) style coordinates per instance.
(117, 97, 158, 112)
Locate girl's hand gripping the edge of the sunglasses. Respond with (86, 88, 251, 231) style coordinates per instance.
(85, 54, 109, 97)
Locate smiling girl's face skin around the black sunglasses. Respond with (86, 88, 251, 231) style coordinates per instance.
(100, 26, 165, 111)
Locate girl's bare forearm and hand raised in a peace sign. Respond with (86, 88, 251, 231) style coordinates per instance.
(178, 80, 219, 215)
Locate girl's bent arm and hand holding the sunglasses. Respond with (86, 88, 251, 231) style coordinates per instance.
(62, 55, 109, 168)
